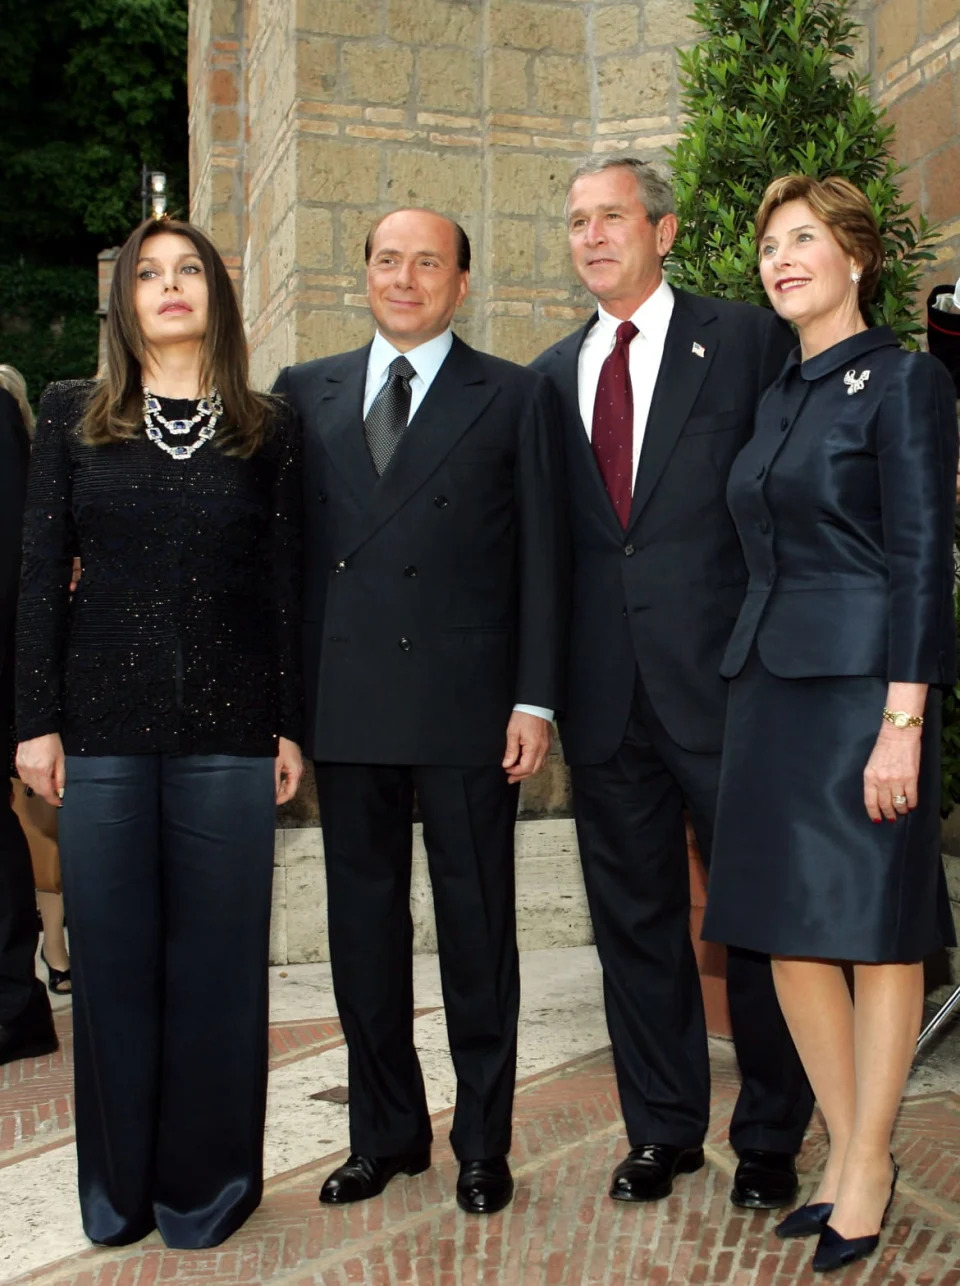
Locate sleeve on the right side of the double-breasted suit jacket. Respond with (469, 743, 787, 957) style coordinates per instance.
(514, 377, 569, 710)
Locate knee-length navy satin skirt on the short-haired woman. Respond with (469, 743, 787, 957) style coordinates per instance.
(703, 647, 956, 963)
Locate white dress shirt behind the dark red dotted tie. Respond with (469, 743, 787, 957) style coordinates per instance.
(577, 278, 673, 481)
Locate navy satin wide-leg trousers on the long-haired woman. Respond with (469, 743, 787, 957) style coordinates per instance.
(60, 755, 275, 1249)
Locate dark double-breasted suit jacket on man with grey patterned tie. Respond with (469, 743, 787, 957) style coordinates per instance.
(275, 338, 567, 766)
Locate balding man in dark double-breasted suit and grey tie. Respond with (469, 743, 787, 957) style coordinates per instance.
(276, 210, 567, 1214)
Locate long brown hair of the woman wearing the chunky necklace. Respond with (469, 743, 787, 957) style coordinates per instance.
(81, 219, 274, 458)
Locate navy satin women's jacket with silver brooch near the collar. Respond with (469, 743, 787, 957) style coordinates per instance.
(724, 327, 957, 684)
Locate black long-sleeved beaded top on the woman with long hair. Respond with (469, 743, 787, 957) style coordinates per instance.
(17, 381, 302, 756)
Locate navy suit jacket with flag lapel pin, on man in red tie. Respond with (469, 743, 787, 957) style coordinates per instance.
(533, 289, 794, 764)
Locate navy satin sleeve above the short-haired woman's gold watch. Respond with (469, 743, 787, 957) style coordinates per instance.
(876, 352, 957, 684)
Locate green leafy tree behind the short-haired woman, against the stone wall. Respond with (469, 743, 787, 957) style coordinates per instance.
(671, 0, 933, 341)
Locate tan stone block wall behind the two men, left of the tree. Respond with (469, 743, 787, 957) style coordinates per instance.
(190, 0, 709, 385)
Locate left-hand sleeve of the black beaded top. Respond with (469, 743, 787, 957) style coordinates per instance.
(17, 385, 81, 741)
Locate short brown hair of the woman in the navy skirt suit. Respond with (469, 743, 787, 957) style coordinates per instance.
(754, 174, 884, 311)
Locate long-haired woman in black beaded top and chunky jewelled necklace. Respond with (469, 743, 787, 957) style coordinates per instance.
(17, 220, 302, 1249)
